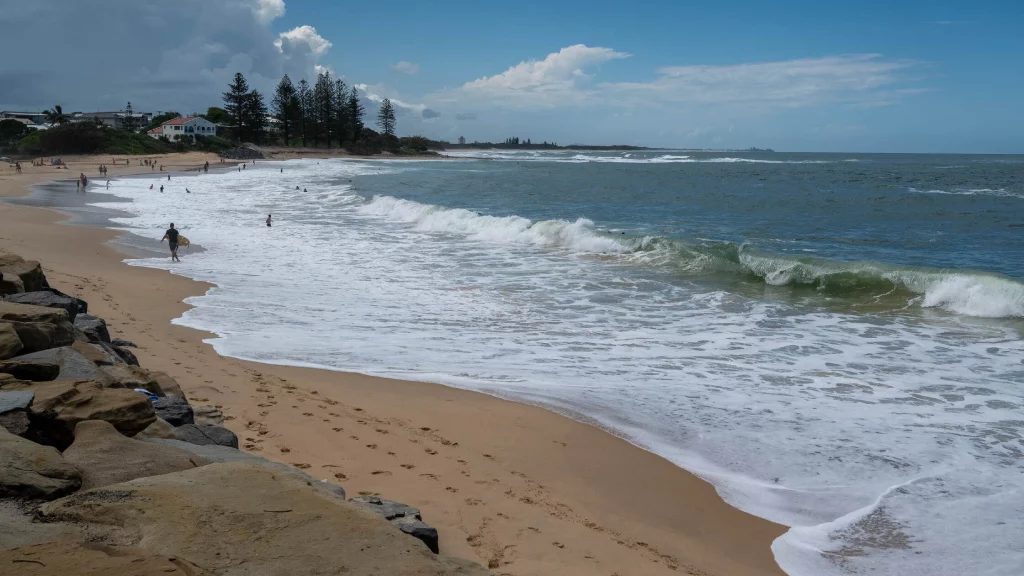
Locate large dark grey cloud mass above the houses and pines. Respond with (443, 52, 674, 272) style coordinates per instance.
(0, 0, 331, 113)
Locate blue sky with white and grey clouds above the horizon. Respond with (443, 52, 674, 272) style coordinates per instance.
(0, 0, 1024, 154)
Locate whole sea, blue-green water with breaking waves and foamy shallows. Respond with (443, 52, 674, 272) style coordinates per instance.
(91, 151, 1024, 576)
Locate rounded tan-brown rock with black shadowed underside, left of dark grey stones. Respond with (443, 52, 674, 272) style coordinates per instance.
(20, 380, 157, 448)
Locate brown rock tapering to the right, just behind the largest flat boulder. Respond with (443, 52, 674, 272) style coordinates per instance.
(63, 420, 210, 490)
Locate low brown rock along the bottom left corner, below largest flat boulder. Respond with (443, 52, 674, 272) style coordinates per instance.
(0, 539, 213, 576)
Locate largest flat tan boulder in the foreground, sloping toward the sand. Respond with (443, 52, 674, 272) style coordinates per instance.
(40, 462, 487, 576)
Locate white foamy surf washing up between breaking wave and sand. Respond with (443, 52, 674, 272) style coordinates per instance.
(88, 161, 1024, 576)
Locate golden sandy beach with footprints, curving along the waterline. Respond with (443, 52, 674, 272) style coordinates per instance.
(0, 155, 785, 575)
